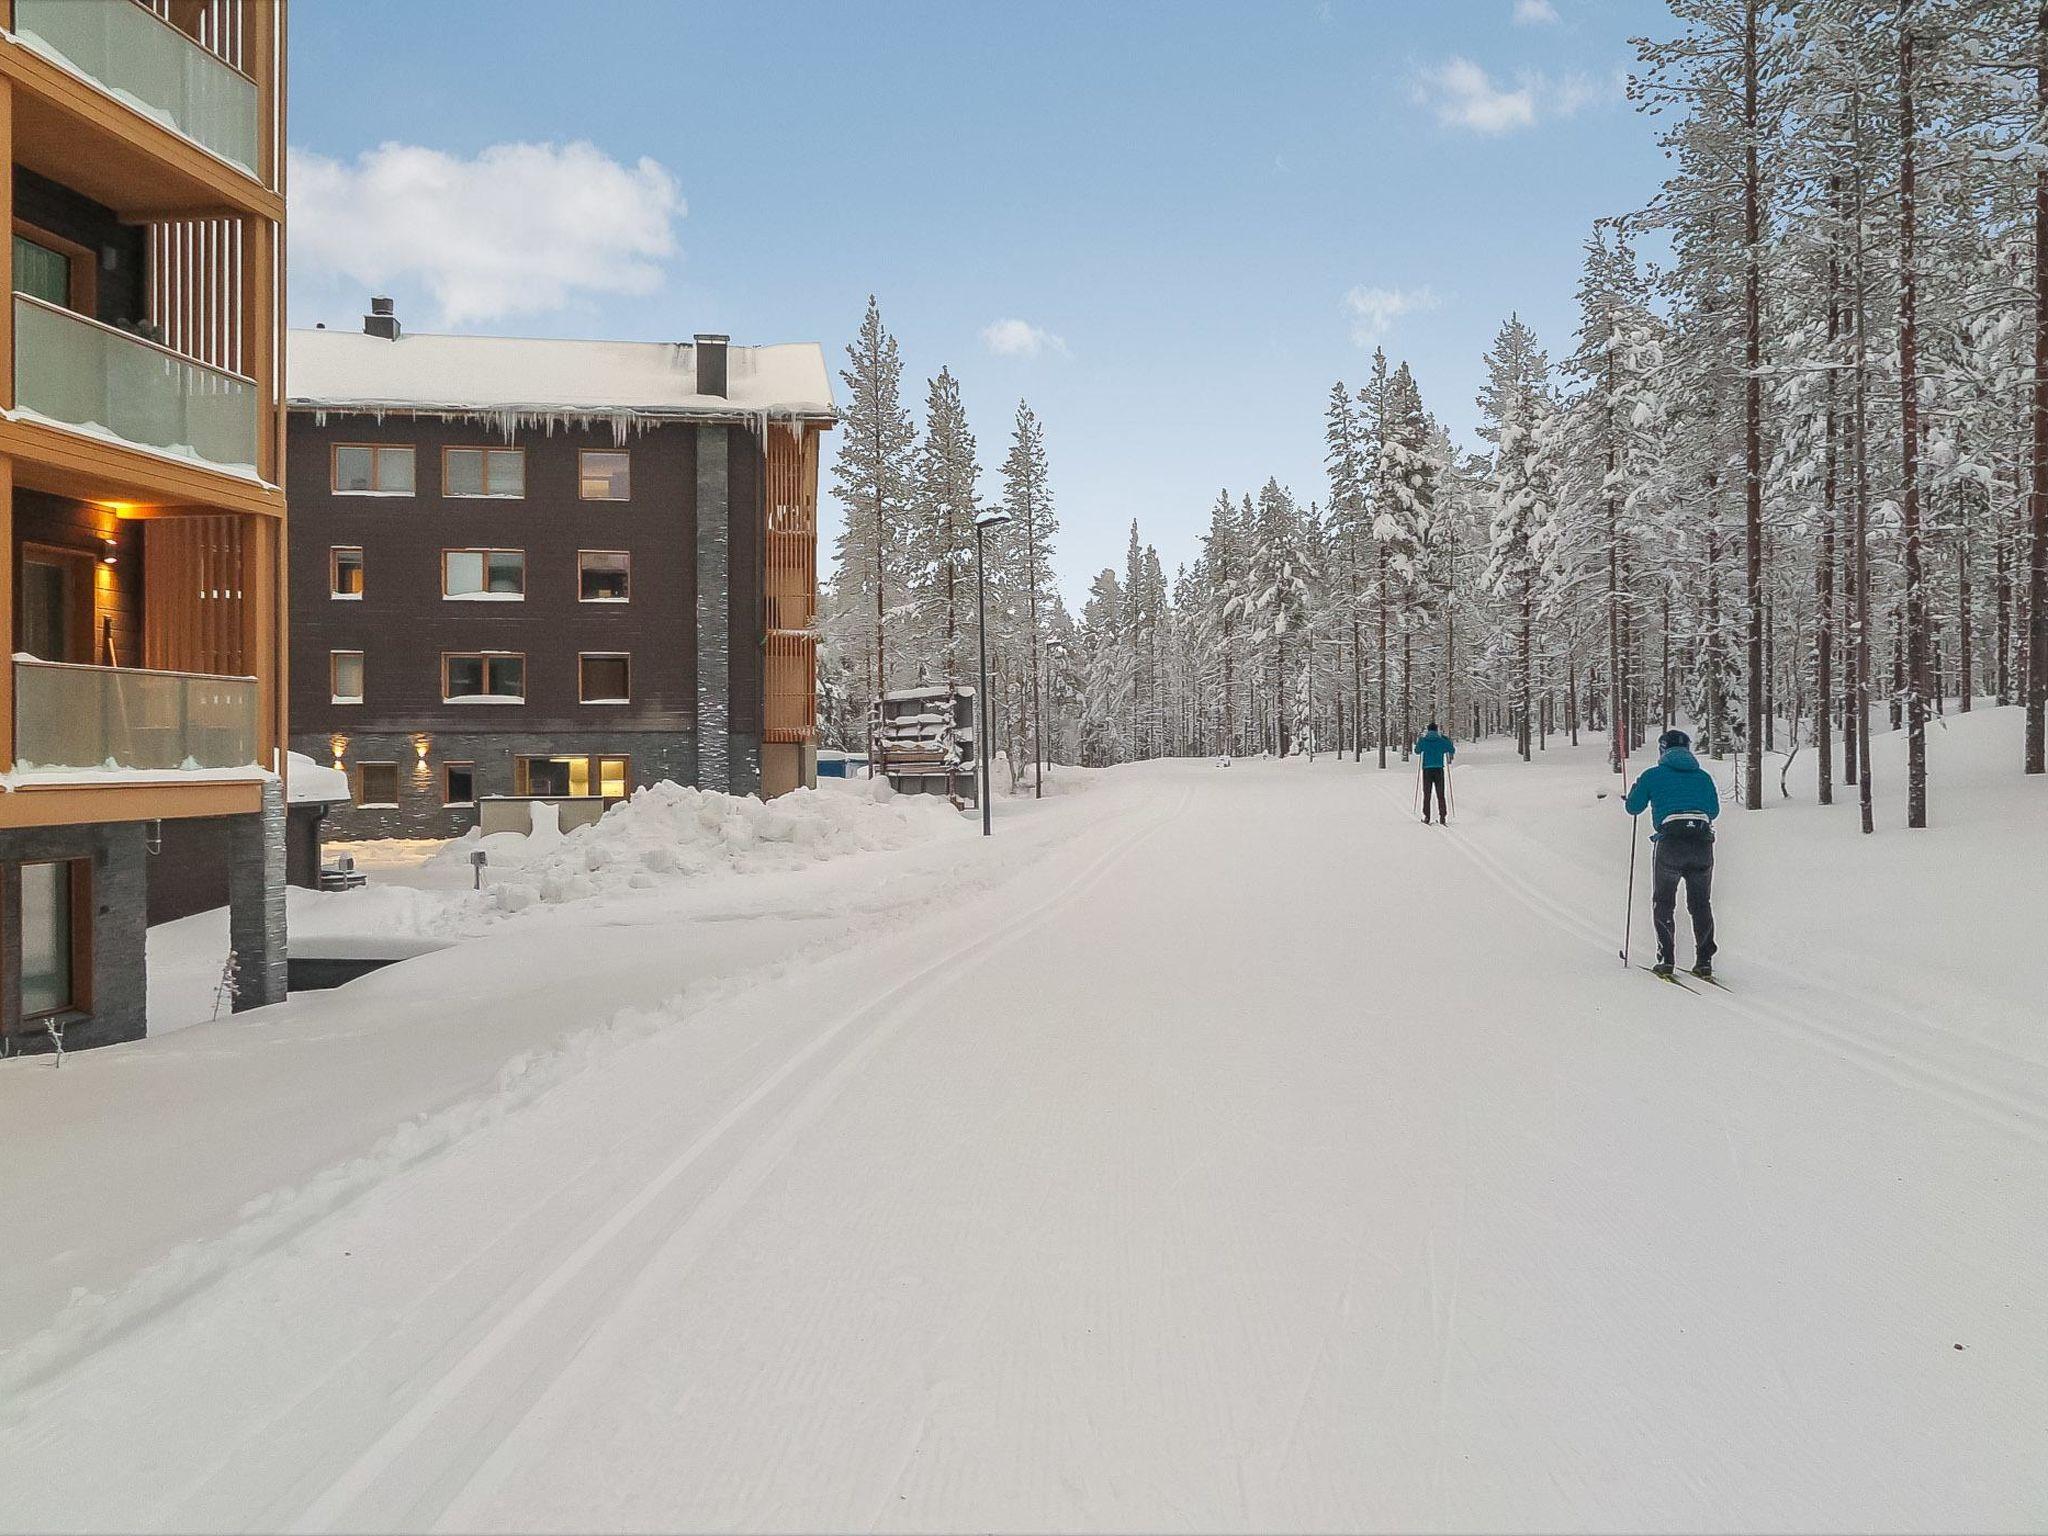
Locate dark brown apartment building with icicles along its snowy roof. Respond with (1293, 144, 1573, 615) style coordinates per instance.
(289, 299, 834, 838)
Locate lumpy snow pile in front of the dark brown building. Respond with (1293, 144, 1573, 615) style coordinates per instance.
(434, 780, 967, 911)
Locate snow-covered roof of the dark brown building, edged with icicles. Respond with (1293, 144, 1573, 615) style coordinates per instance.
(285, 330, 834, 420)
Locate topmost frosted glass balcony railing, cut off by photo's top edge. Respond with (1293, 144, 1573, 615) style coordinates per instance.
(14, 0, 258, 176)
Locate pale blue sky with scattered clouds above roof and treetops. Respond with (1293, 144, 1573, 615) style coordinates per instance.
(291, 0, 1669, 600)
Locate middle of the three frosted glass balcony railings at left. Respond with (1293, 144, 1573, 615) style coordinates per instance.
(14, 293, 256, 471)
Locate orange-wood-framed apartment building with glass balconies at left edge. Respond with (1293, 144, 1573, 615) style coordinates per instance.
(0, 0, 285, 1053)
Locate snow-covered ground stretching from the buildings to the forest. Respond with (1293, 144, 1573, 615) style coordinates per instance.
(0, 711, 2048, 1530)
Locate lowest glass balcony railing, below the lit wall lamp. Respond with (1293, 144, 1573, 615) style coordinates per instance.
(14, 657, 256, 772)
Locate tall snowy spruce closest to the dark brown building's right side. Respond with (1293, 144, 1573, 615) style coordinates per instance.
(825, 295, 918, 749)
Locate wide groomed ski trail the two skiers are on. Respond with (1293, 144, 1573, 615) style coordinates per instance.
(0, 762, 2048, 1530)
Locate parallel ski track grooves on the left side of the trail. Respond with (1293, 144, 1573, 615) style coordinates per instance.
(287, 791, 1192, 1532)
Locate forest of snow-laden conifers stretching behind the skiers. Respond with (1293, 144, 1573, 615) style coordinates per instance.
(821, 0, 2048, 829)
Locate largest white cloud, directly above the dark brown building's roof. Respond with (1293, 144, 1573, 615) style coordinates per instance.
(289, 141, 688, 326)
